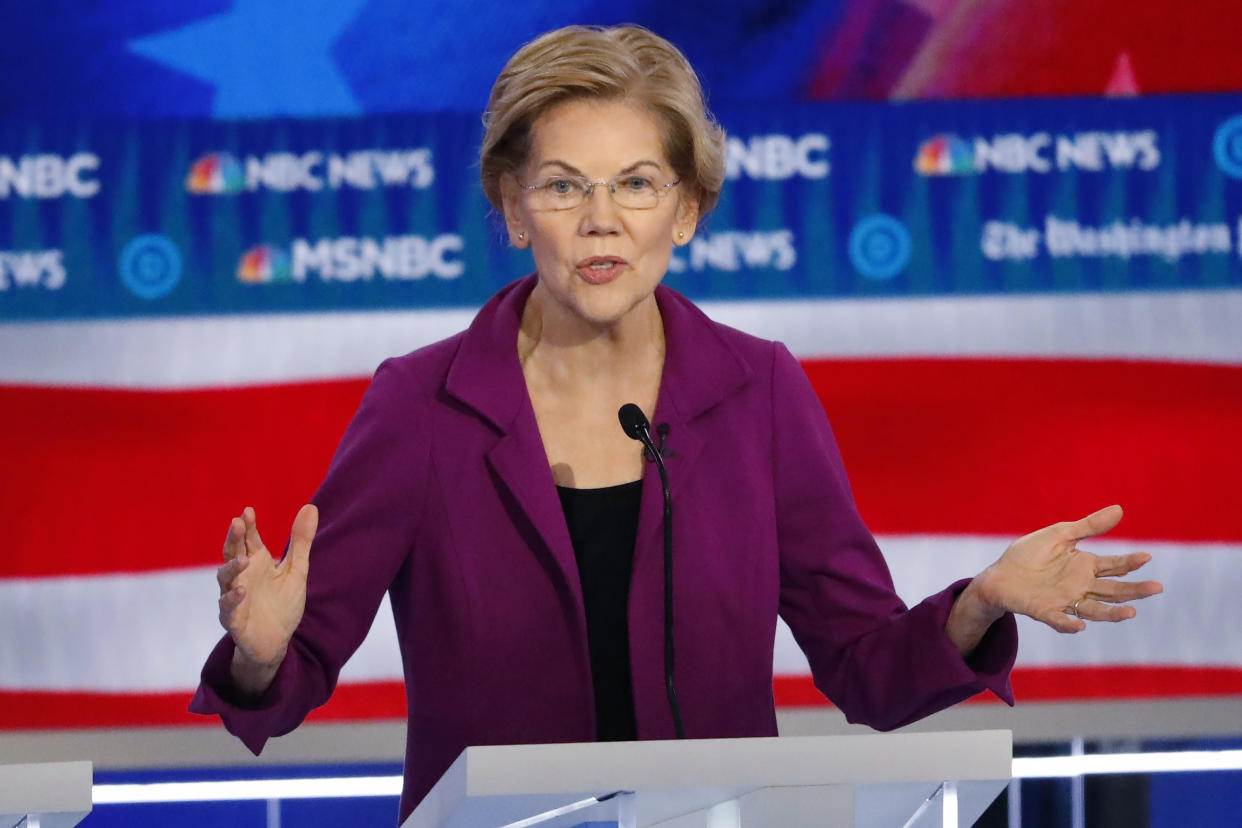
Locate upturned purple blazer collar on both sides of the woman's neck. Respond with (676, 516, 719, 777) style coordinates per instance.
(445, 274, 754, 432)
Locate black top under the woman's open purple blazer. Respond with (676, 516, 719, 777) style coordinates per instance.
(556, 480, 642, 741)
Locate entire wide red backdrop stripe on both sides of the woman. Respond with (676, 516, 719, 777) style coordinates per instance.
(0, 359, 1242, 577)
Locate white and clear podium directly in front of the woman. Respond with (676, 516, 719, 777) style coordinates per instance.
(402, 730, 1013, 828)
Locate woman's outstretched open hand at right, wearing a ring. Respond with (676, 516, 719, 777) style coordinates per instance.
(945, 506, 1164, 653)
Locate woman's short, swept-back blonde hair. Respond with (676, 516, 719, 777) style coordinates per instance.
(479, 26, 724, 217)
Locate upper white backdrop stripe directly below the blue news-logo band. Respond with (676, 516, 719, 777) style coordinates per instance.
(0, 289, 1242, 389)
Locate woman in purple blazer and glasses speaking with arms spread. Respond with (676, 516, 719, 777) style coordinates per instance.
(193, 27, 1160, 819)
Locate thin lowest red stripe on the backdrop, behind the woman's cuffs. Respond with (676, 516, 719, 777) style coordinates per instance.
(0, 665, 1242, 730)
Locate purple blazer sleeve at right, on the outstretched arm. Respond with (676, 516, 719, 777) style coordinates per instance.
(773, 343, 1017, 730)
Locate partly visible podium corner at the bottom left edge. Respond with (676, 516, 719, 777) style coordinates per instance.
(0, 762, 93, 828)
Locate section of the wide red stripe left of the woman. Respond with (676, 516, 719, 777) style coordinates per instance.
(0, 380, 368, 577)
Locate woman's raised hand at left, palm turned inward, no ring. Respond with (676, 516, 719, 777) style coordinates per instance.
(216, 504, 319, 696)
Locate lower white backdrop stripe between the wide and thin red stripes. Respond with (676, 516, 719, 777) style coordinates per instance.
(0, 535, 1242, 693)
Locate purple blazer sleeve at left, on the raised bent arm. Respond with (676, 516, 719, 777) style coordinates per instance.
(190, 360, 428, 754)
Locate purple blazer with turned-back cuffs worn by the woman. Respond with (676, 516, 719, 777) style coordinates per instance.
(190, 277, 1017, 821)
